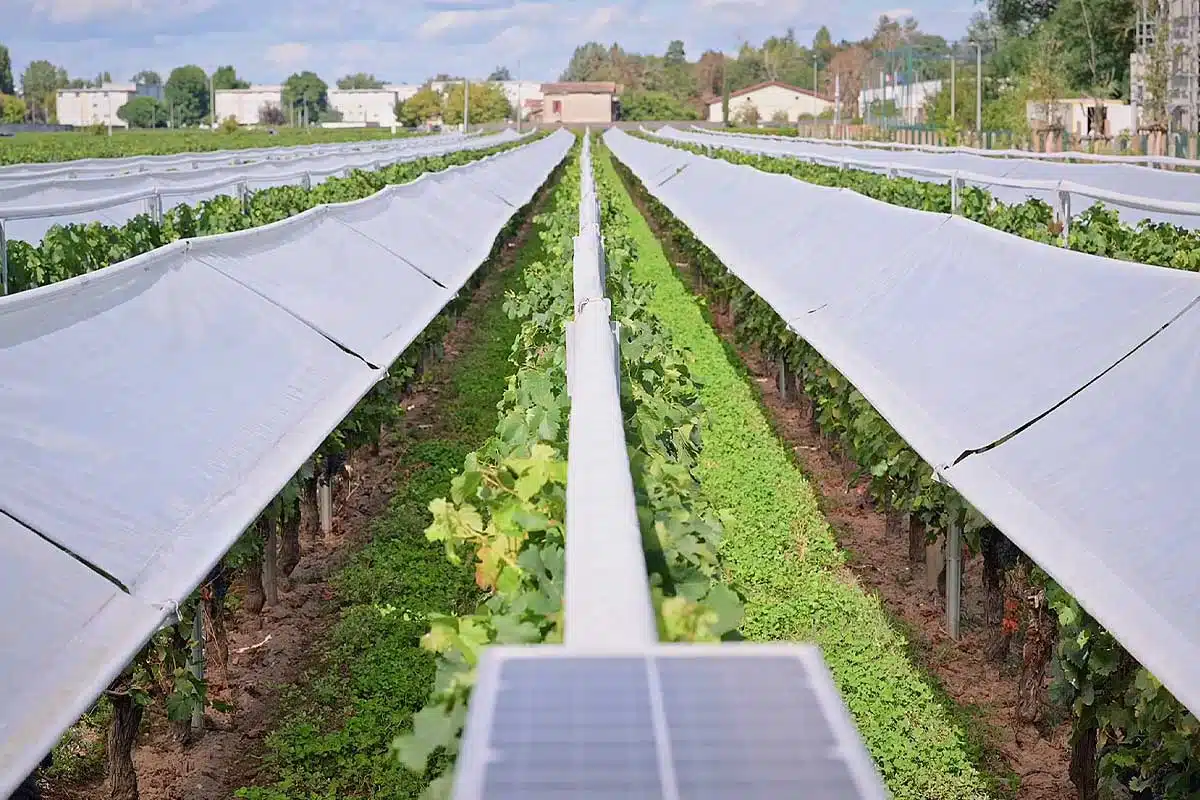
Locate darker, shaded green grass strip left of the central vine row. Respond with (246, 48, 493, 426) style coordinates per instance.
(236, 206, 544, 800)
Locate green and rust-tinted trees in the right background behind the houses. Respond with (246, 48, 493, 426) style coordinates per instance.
(560, 0, 1142, 132)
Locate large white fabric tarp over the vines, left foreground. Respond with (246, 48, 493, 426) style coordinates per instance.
(0, 132, 574, 796)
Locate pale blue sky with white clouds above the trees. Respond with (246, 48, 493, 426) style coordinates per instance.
(0, 0, 977, 83)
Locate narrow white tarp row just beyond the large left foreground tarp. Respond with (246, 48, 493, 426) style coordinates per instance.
(0, 130, 518, 243)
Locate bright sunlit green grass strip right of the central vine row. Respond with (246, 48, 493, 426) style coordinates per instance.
(598, 143, 989, 800)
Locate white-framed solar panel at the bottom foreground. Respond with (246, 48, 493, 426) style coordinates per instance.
(454, 643, 887, 800)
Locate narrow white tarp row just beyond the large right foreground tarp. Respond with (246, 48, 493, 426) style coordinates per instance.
(658, 127, 1200, 228)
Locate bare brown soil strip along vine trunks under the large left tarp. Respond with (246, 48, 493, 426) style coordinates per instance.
(43, 205, 545, 800)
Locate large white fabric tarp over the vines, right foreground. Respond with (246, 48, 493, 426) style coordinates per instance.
(606, 132, 1200, 709)
